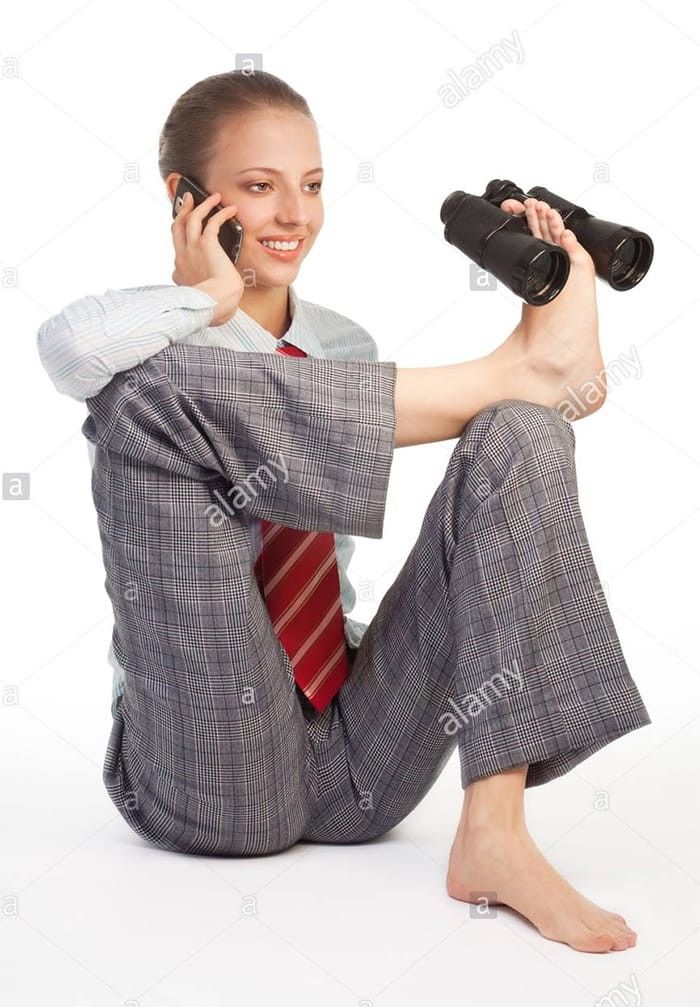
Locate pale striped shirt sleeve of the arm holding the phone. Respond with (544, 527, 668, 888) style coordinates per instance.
(36, 286, 217, 402)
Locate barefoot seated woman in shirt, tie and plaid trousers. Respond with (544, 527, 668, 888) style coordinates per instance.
(39, 71, 650, 952)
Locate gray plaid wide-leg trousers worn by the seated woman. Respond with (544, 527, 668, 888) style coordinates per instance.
(83, 345, 651, 855)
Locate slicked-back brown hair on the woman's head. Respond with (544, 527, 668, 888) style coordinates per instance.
(158, 69, 313, 185)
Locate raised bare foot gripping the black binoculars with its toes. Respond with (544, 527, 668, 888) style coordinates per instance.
(492, 199, 607, 421)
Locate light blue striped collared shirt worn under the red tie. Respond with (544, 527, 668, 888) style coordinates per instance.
(37, 284, 378, 709)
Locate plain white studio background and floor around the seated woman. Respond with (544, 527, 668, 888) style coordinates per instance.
(0, 0, 700, 1007)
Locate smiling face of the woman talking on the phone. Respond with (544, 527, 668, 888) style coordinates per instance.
(202, 109, 323, 287)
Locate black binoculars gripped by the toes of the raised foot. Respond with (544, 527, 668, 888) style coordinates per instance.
(440, 178, 654, 305)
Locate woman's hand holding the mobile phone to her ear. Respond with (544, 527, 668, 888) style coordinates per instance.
(171, 192, 245, 326)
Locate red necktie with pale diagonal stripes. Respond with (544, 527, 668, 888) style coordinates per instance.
(254, 344, 349, 711)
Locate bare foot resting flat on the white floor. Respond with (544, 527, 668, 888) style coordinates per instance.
(446, 820, 637, 953)
